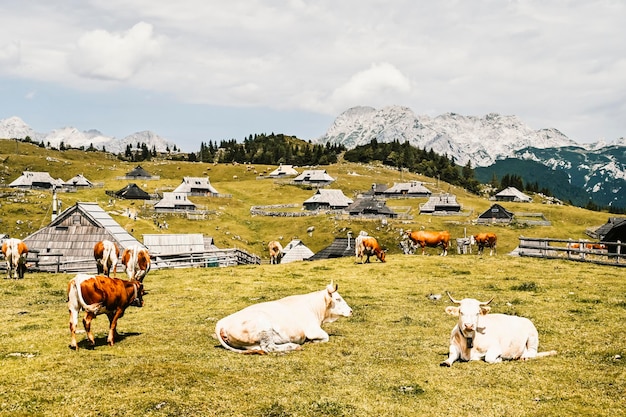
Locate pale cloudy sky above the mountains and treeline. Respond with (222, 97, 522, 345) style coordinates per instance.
(0, 0, 626, 151)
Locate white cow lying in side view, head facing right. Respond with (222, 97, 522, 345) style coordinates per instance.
(215, 281, 352, 355)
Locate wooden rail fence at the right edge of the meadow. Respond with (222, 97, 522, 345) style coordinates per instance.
(518, 236, 626, 266)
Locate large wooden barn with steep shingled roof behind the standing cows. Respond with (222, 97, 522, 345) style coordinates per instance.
(23, 202, 143, 273)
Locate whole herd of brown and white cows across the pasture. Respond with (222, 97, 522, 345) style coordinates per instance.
(2, 231, 556, 367)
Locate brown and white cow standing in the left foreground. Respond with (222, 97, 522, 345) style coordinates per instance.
(67, 274, 144, 350)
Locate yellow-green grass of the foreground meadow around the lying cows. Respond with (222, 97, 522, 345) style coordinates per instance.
(0, 255, 626, 416)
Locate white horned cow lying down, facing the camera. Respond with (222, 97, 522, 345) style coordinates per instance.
(440, 293, 556, 366)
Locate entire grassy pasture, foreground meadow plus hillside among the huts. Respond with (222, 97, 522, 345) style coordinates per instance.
(0, 141, 626, 416)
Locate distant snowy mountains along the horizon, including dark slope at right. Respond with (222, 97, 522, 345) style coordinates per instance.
(0, 106, 626, 208)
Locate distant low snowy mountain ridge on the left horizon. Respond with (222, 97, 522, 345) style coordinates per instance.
(0, 117, 176, 153)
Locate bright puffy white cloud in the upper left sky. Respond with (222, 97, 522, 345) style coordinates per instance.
(68, 22, 160, 81)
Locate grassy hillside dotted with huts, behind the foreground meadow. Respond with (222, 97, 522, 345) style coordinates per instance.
(0, 140, 608, 258)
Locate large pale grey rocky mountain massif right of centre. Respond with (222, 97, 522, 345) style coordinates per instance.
(317, 106, 576, 166)
